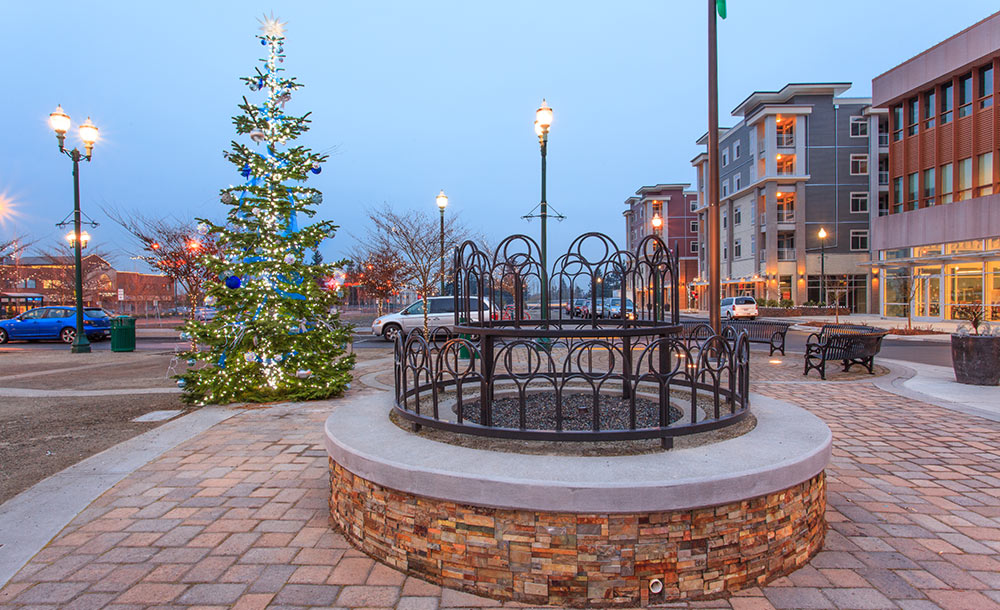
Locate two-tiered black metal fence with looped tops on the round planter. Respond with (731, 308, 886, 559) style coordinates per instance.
(395, 233, 750, 446)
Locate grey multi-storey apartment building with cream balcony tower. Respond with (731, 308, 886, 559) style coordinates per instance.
(691, 83, 888, 312)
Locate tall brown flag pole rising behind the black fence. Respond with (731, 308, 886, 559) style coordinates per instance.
(705, 0, 726, 334)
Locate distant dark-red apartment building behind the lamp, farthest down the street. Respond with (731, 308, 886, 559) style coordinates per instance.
(622, 183, 699, 307)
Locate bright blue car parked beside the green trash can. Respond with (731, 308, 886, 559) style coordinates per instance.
(0, 305, 111, 344)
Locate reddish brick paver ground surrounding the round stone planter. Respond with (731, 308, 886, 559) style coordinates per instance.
(0, 354, 1000, 610)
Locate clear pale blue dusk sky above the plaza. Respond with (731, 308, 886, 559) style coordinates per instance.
(0, 0, 996, 269)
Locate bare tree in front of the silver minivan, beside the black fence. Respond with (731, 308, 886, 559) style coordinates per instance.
(364, 204, 469, 337)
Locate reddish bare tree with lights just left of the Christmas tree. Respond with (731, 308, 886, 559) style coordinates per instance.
(104, 209, 218, 318)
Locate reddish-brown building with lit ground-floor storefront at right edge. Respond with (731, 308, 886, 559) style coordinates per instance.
(872, 13, 1000, 321)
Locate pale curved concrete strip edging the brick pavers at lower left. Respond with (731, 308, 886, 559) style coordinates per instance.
(0, 407, 240, 588)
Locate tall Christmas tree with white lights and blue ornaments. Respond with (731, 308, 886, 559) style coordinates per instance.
(177, 17, 354, 404)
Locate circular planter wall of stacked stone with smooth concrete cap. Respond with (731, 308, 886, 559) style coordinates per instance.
(326, 393, 831, 606)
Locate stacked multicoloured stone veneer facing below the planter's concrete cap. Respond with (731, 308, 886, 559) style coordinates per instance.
(330, 460, 826, 606)
